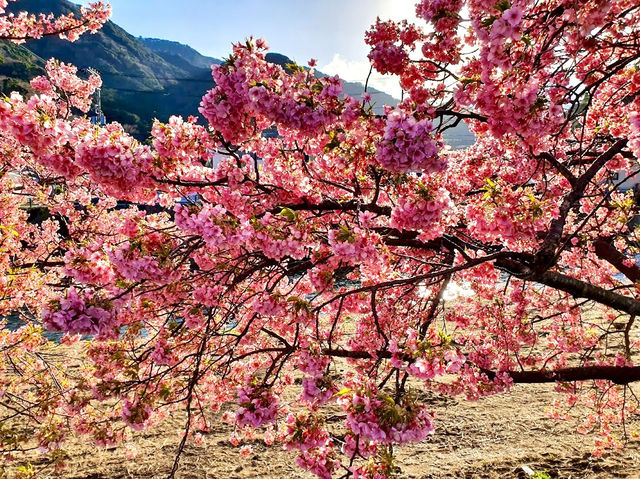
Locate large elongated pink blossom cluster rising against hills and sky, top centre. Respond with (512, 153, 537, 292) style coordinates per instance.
(200, 40, 360, 142)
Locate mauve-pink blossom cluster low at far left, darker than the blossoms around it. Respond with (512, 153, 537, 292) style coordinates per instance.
(42, 288, 118, 337)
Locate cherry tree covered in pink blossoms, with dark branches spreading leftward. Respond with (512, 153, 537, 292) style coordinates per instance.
(0, 0, 640, 478)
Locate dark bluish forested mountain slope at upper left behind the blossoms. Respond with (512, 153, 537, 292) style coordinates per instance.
(0, 0, 218, 136)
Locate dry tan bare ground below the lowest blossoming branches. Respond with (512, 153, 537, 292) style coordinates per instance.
(10, 385, 640, 479)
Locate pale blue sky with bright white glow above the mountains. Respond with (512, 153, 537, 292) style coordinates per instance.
(83, 0, 415, 96)
